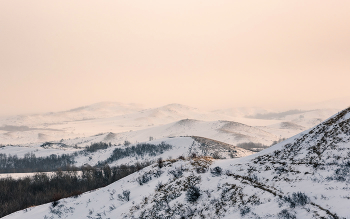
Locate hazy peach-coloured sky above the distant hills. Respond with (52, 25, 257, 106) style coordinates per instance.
(0, 0, 350, 115)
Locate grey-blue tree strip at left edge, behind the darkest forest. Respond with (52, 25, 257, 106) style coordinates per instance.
(0, 153, 74, 173)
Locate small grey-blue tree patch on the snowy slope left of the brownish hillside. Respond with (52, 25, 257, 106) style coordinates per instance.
(99, 142, 173, 165)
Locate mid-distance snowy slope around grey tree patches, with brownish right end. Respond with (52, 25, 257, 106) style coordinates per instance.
(0, 134, 253, 167)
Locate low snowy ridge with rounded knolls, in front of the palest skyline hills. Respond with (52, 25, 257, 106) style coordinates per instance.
(7, 119, 282, 149)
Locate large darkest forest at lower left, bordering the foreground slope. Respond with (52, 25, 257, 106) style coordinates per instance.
(0, 162, 151, 218)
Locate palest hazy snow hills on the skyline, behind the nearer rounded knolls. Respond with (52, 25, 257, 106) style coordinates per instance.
(0, 102, 337, 145)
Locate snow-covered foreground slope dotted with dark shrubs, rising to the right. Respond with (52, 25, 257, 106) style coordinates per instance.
(5, 108, 350, 219)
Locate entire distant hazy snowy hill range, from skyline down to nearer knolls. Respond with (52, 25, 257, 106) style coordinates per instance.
(0, 102, 339, 146)
